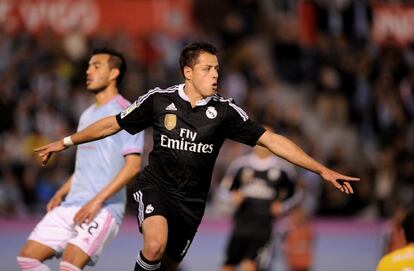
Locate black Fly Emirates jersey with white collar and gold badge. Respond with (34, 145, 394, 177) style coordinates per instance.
(116, 84, 265, 216)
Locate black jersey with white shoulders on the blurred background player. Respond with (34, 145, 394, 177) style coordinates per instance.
(223, 154, 301, 235)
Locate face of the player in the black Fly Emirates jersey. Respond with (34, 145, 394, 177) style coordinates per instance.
(190, 53, 219, 97)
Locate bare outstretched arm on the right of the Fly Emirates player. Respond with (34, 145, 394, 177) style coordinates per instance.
(257, 131, 359, 194)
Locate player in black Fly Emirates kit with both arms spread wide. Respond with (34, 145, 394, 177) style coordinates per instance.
(35, 42, 359, 271)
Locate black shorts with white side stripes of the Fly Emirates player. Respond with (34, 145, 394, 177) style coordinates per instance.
(133, 183, 201, 263)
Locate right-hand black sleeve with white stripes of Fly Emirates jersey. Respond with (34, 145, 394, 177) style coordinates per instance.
(223, 102, 266, 146)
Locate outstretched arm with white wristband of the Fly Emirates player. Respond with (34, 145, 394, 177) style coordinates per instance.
(34, 116, 121, 165)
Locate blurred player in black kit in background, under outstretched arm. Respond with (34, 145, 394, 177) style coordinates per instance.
(220, 134, 303, 271)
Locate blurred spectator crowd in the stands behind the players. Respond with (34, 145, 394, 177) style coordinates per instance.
(0, 0, 414, 221)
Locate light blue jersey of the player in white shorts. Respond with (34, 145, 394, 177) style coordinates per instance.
(62, 95, 144, 224)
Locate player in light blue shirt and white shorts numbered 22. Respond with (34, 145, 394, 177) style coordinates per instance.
(17, 49, 144, 271)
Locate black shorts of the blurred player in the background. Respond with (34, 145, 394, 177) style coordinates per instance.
(224, 233, 271, 265)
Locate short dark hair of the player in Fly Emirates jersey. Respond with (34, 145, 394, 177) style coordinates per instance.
(180, 42, 217, 75)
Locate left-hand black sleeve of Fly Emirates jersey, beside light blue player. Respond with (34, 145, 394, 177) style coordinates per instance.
(116, 93, 153, 134)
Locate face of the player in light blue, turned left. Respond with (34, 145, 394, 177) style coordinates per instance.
(86, 54, 111, 92)
